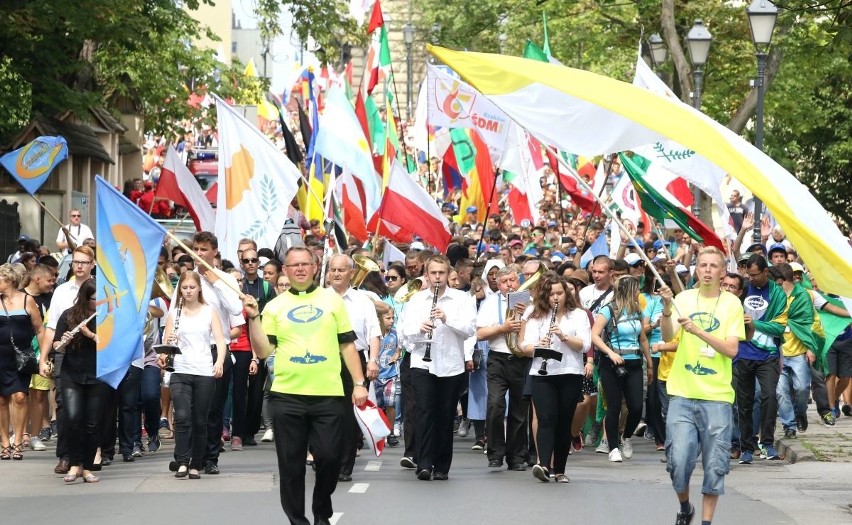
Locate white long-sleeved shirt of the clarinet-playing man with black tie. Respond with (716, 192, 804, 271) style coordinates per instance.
(400, 288, 476, 377)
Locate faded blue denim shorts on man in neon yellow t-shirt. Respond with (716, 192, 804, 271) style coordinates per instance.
(666, 396, 733, 496)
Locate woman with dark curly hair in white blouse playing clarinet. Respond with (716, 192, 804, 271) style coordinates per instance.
(521, 274, 591, 483)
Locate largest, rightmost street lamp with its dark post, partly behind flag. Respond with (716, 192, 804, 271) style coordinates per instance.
(746, 0, 778, 243)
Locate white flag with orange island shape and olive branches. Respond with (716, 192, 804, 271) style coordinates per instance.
(216, 97, 301, 261)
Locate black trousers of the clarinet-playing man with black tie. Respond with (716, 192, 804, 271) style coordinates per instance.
(411, 368, 465, 474)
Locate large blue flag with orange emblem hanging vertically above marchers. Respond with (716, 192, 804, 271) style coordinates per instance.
(95, 177, 166, 388)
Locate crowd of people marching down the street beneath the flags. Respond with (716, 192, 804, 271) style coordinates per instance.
(0, 188, 852, 523)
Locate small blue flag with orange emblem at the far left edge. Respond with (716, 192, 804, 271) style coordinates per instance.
(0, 137, 68, 195)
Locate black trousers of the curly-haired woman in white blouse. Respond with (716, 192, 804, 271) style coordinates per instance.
(528, 374, 583, 474)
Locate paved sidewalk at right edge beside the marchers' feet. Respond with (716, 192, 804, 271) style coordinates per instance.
(775, 404, 852, 463)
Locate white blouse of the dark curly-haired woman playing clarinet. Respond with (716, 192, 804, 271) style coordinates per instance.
(521, 306, 592, 376)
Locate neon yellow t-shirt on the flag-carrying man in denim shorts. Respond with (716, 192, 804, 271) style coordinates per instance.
(666, 290, 745, 403)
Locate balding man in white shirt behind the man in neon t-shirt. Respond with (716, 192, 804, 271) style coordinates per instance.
(326, 254, 382, 481)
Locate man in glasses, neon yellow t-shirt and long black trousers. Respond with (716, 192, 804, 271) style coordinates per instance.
(243, 247, 367, 524)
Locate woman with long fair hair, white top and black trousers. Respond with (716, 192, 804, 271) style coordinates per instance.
(159, 272, 226, 479)
